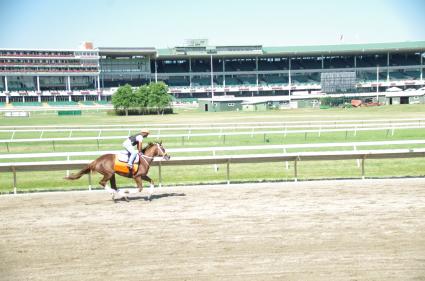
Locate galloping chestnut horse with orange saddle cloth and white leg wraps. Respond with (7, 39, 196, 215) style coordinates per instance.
(65, 141, 170, 201)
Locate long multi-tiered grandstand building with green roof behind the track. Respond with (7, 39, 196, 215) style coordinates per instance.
(0, 40, 425, 103)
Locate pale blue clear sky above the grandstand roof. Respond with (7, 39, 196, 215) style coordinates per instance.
(0, 0, 425, 49)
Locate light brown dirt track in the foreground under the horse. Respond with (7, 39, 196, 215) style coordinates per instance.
(0, 179, 425, 281)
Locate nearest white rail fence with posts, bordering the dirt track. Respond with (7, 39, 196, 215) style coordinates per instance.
(0, 148, 425, 193)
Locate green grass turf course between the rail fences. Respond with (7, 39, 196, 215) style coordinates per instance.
(0, 105, 425, 192)
